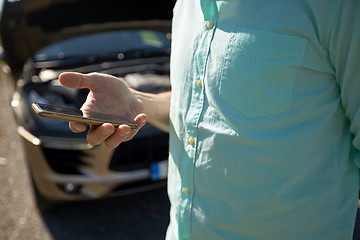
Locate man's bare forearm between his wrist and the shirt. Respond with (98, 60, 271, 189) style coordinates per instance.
(131, 90, 171, 132)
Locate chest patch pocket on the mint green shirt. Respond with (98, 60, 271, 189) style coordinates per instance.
(219, 27, 307, 118)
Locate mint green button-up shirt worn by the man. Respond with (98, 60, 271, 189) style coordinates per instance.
(167, 0, 360, 240)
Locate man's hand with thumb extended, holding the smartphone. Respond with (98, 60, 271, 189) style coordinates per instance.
(59, 72, 147, 148)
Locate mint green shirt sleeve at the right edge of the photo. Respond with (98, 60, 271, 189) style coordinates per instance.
(329, 0, 360, 163)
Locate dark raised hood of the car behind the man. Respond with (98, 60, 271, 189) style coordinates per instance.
(0, 0, 176, 76)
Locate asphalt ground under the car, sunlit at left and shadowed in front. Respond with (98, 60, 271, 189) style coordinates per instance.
(0, 66, 169, 240)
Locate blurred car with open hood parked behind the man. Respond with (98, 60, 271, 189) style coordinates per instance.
(0, 0, 175, 211)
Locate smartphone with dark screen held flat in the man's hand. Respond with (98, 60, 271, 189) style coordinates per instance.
(31, 103, 137, 129)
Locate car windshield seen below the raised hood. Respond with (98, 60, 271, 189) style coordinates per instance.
(34, 30, 170, 61)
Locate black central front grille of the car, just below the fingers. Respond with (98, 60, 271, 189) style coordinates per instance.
(109, 133, 169, 171)
